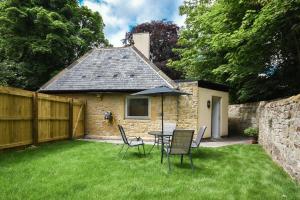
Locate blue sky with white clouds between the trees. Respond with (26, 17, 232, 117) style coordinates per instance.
(80, 0, 184, 46)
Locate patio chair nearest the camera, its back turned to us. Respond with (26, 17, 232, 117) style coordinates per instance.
(162, 130, 194, 171)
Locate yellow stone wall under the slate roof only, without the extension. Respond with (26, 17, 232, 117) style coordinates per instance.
(63, 93, 178, 139)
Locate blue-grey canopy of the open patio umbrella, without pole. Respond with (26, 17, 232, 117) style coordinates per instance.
(131, 86, 191, 96)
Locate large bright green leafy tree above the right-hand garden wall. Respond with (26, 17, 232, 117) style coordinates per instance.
(169, 0, 300, 102)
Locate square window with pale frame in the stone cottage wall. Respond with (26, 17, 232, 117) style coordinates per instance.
(125, 96, 150, 119)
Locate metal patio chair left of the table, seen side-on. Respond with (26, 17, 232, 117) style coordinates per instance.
(118, 125, 146, 159)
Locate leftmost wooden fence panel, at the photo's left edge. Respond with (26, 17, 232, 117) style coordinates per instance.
(0, 87, 33, 148)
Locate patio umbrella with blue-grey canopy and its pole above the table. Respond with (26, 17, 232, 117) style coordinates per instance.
(131, 86, 191, 133)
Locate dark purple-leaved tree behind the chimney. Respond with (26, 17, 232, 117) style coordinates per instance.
(123, 20, 181, 79)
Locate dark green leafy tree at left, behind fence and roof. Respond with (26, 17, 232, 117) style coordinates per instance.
(0, 0, 108, 90)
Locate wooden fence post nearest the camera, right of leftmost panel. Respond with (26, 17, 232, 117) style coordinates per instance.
(32, 92, 39, 145)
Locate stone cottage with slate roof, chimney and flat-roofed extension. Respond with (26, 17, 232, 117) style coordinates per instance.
(39, 33, 228, 138)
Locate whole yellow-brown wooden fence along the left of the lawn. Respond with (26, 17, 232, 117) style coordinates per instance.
(0, 86, 85, 149)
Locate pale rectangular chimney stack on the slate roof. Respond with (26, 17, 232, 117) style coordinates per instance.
(132, 32, 150, 59)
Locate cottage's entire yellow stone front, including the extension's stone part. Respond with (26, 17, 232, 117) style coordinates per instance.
(58, 82, 198, 140)
